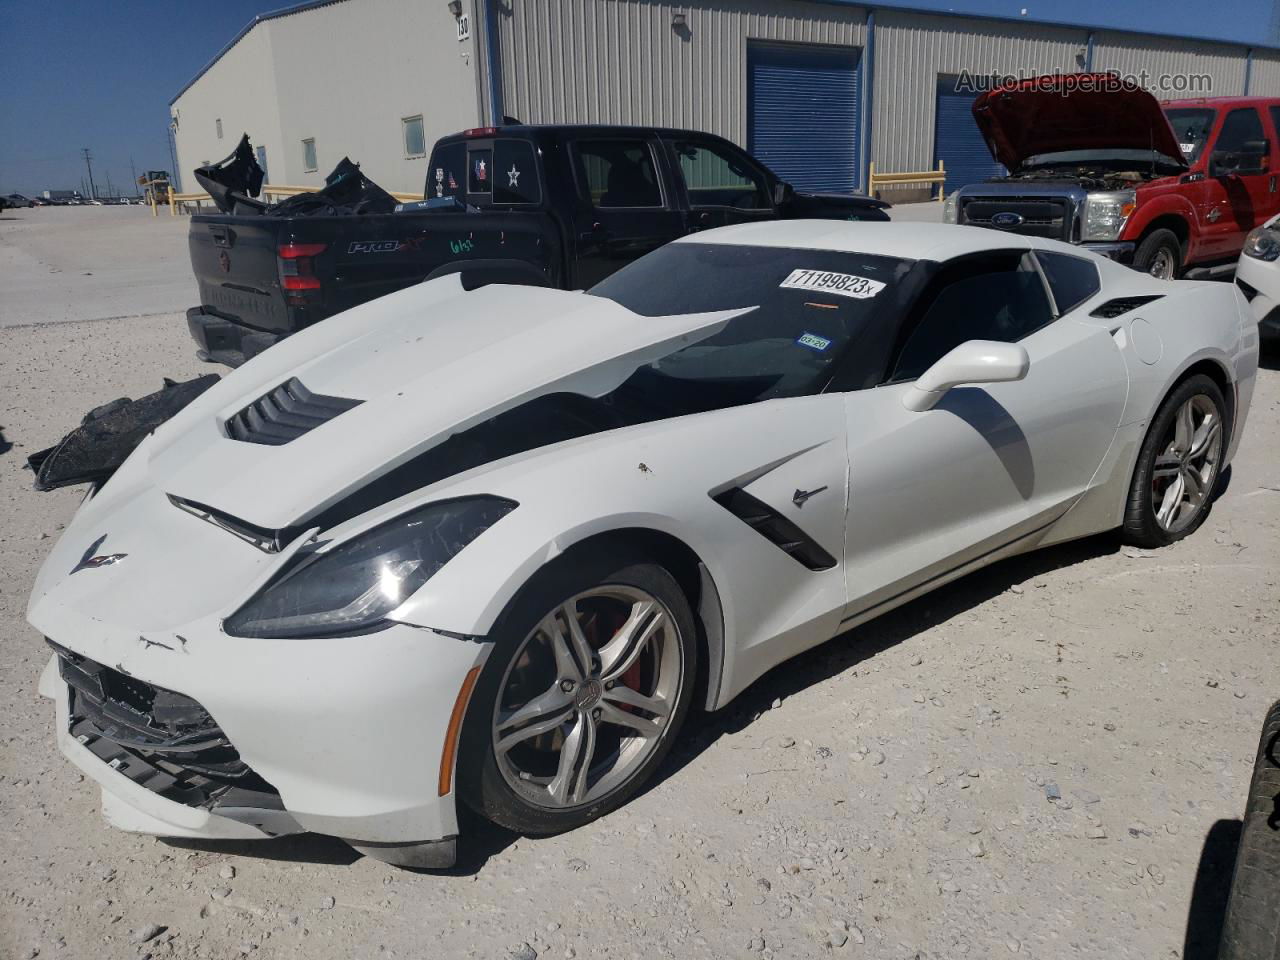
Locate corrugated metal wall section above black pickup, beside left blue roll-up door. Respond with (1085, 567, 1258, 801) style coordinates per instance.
(498, 0, 867, 145)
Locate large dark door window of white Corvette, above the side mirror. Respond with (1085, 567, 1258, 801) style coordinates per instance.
(890, 256, 1053, 383)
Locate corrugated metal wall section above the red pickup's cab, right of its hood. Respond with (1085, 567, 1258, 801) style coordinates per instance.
(1093, 31, 1244, 100)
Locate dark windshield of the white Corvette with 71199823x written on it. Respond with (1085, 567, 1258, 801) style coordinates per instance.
(589, 243, 910, 411)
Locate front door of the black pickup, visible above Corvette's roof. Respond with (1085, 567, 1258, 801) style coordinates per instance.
(667, 136, 777, 232)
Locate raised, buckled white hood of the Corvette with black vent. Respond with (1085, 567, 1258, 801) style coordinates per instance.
(136, 274, 742, 530)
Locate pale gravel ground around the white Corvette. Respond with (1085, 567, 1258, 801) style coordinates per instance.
(0, 211, 1280, 960)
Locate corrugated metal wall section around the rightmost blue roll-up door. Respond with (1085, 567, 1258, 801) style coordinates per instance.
(872, 10, 1088, 186)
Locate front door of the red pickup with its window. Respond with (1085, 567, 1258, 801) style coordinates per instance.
(1202, 106, 1271, 259)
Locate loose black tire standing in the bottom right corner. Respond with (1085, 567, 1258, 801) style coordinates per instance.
(1219, 701, 1280, 960)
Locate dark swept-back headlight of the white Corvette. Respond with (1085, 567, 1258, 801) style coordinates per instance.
(223, 497, 516, 637)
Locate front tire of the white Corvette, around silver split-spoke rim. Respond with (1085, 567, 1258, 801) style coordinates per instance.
(458, 550, 699, 836)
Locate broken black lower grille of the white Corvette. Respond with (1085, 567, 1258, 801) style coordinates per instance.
(50, 643, 283, 810)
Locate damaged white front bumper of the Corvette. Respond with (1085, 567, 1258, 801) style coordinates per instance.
(41, 616, 488, 868)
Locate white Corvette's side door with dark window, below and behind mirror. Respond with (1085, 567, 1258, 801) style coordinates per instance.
(844, 252, 1128, 626)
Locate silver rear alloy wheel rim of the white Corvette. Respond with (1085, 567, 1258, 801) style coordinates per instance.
(1151, 393, 1222, 534)
